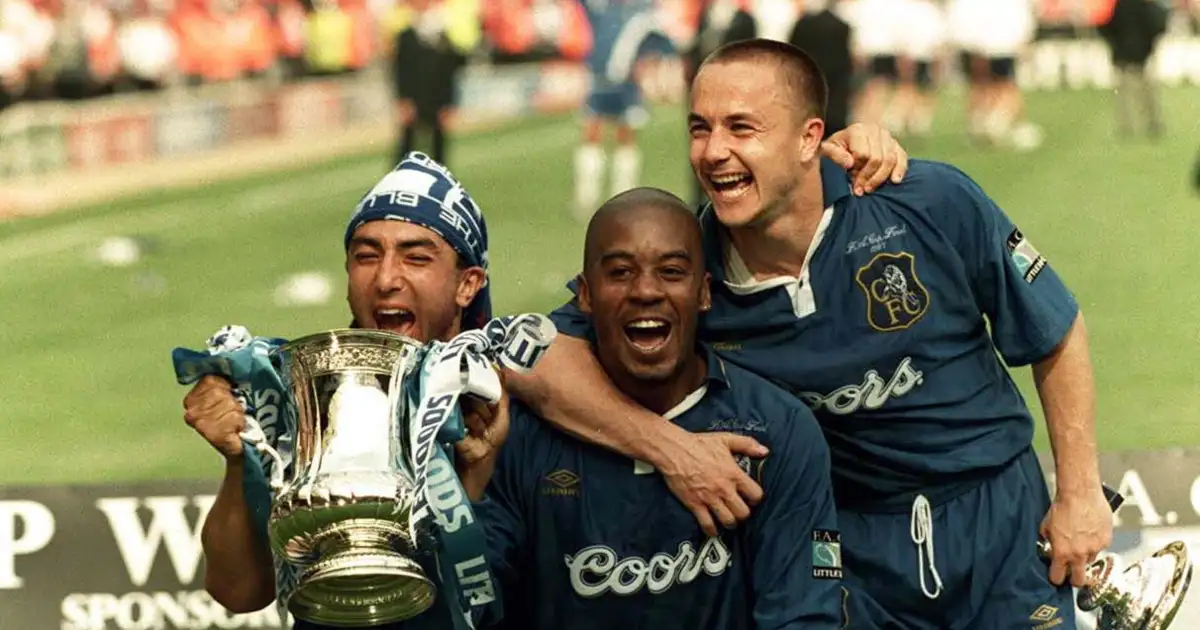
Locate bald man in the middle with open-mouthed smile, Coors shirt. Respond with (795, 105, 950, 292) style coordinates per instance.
(451, 188, 845, 630)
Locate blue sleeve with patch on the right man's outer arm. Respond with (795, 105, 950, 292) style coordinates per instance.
(943, 167, 1079, 367)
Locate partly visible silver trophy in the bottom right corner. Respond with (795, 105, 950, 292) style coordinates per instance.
(1038, 486, 1192, 630)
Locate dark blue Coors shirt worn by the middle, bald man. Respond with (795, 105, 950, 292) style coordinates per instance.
(475, 354, 845, 630)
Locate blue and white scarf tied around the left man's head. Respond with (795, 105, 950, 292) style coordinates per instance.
(346, 151, 492, 330)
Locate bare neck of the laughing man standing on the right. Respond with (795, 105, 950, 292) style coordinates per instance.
(728, 166, 824, 280)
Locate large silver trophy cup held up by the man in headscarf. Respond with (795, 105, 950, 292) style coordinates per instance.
(268, 330, 436, 628)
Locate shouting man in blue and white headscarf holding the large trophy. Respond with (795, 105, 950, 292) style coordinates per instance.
(184, 152, 492, 629)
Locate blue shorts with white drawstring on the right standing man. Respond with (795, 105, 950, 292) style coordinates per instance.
(838, 449, 1075, 630)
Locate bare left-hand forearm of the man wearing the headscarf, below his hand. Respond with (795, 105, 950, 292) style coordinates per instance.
(200, 456, 275, 613)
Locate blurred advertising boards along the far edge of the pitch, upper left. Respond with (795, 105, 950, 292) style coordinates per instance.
(0, 62, 587, 180)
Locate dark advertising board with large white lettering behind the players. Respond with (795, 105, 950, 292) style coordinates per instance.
(0, 451, 1200, 630)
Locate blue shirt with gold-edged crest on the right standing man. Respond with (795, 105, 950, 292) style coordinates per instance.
(553, 160, 1079, 508)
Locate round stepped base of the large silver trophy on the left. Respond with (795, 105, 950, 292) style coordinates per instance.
(288, 518, 437, 628)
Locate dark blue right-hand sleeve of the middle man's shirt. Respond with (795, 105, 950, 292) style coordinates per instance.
(746, 407, 846, 630)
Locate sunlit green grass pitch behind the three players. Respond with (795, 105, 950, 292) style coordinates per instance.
(0, 85, 1200, 484)
